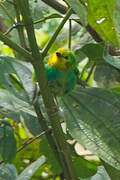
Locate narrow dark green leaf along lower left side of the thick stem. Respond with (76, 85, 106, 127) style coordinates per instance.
(40, 138, 62, 175)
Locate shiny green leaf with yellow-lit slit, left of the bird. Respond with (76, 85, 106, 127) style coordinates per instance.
(0, 56, 34, 102)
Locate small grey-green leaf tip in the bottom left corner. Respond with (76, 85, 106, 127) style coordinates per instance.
(0, 164, 17, 180)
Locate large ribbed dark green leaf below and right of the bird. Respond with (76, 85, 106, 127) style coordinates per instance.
(63, 87, 120, 170)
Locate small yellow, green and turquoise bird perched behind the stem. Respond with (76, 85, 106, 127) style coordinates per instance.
(45, 48, 77, 96)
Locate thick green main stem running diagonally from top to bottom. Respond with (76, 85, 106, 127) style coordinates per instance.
(16, 0, 77, 180)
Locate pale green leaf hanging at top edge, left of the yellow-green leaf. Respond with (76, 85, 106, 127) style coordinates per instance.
(66, 0, 87, 26)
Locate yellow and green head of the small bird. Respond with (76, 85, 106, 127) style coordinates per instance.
(48, 48, 76, 71)
